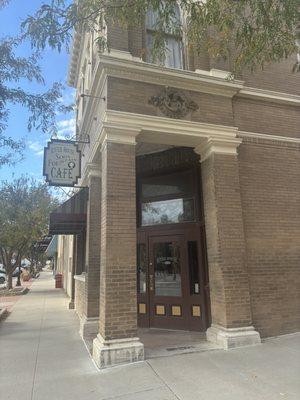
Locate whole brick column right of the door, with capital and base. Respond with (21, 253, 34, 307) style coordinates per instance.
(195, 138, 260, 349)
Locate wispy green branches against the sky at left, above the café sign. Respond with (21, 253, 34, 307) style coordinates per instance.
(0, 0, 74, 168)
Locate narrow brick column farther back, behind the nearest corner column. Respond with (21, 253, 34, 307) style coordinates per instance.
(79, 165, 101, 338)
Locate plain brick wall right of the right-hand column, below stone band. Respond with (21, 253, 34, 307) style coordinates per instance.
(239, 142, 300, 336)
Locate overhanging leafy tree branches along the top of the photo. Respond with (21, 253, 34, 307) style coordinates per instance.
(22, 0, 300, 72)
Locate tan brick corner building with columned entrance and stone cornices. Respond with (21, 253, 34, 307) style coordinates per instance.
(50, 6, 300, 367)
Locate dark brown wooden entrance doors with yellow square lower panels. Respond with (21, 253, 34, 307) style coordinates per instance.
(137, 224, 209, 331)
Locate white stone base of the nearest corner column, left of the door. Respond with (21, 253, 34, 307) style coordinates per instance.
(93, 334, 144, 369)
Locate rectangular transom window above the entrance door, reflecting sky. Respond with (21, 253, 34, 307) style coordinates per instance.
(142, 199, 195, 226)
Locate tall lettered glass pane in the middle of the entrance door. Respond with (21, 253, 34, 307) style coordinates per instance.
(153, 242, 181, 296)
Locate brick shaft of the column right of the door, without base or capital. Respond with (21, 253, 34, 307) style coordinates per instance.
(201, 154, 252, 328)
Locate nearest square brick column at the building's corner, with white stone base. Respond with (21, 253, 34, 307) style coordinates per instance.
(93, 130, 144, 368)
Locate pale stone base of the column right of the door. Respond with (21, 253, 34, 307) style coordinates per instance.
(206, 325, 261, 350)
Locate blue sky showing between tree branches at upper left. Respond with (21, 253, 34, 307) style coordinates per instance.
(0, 0, 74, 180)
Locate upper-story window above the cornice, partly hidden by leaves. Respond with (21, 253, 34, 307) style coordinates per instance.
(146, 6, 183, 69)
